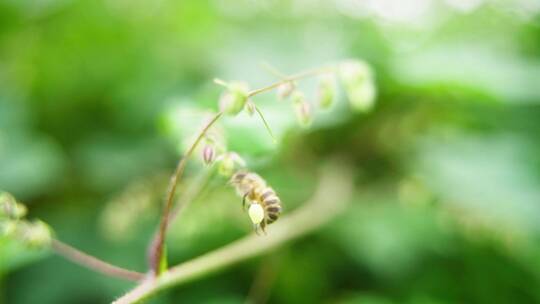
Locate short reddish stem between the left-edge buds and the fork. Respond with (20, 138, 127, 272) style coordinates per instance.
(51, 239, 145, 281)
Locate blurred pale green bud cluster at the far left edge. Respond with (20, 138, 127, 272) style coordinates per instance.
(0, 192, 51, 248)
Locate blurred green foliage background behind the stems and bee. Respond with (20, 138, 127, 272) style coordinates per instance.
(0, 0, 540, 304)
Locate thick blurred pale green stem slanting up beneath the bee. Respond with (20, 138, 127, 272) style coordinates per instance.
(113, 163, 353, 304)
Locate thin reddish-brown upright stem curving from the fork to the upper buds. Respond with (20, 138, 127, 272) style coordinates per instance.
(149, 112, 223, 275)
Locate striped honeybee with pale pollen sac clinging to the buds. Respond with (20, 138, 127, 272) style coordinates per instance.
(231, 171, 281, 233)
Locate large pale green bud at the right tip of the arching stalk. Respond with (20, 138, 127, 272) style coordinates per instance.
(340, 60, 377, 112)
